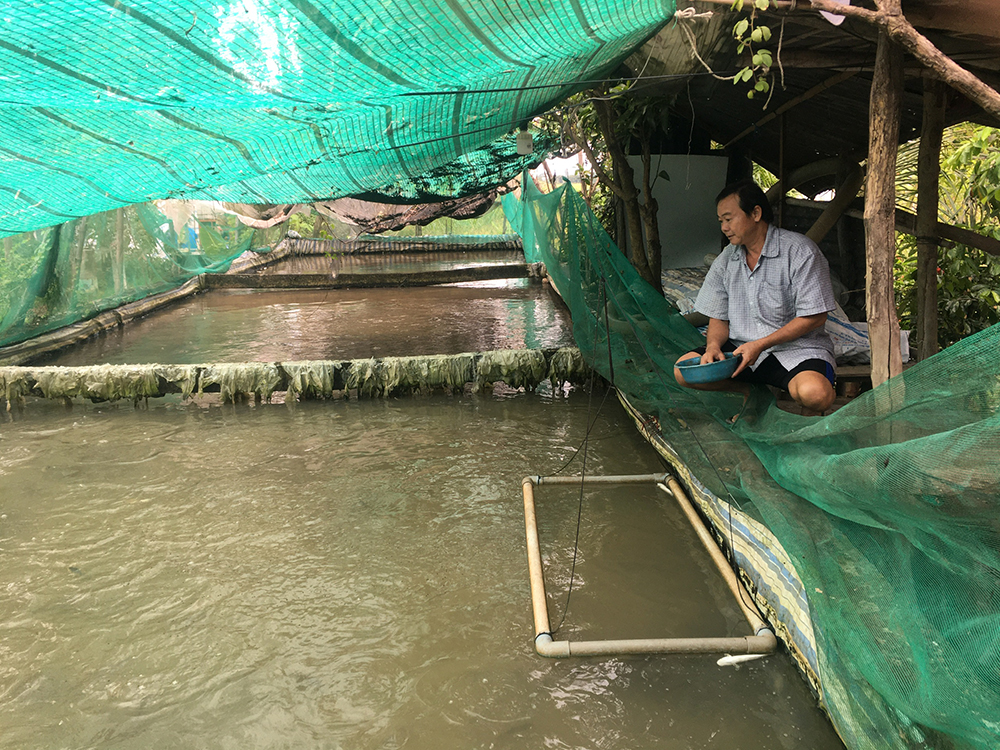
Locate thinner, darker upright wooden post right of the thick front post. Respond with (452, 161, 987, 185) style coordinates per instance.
(916, 77, 946, 360)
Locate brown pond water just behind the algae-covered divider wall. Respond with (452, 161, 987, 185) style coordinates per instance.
(39, 279, 573, 365)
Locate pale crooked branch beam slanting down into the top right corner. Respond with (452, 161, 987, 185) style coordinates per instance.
(810, 0, 1000, 120)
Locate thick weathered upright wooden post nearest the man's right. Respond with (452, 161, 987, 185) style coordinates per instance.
(865, 17, 903, 387)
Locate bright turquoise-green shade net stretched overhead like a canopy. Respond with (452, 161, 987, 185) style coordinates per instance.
(0, 0, 675, 237)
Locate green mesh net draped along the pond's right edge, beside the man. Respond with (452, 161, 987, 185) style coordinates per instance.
(504, 177, 1000, 750)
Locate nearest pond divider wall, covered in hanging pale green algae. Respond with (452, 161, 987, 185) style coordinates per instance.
(0, 347, 590, 410)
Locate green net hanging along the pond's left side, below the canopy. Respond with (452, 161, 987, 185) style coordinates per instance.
(0, 201, 258, 345)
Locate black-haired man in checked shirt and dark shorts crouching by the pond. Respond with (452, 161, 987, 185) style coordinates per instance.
(674, 180, 836, 416)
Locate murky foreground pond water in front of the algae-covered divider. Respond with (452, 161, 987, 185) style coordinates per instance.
(0, 392, 839, 750)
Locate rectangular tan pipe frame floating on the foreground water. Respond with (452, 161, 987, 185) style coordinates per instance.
(521, 474, 778, 658)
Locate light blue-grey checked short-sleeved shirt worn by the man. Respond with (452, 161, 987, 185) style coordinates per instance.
(695, 226, 836, 370)
